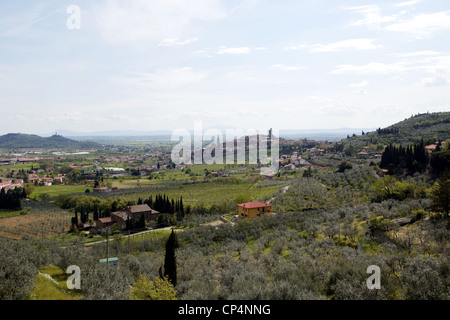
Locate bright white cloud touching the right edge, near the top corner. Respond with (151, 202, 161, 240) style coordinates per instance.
(385, 11, 450, 38)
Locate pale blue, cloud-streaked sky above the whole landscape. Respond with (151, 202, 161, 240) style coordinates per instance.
(0, 0, 450, 134)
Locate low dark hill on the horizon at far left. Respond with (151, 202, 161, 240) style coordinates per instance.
(0, 133, 101, 149)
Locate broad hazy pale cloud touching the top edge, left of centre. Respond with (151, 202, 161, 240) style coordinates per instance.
(94, 0, 227, 45)
